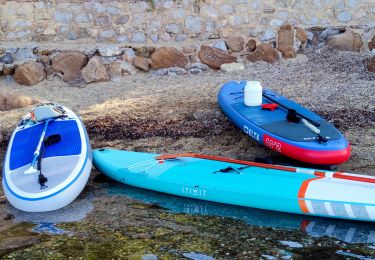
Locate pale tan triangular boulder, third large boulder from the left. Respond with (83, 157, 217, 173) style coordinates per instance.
(82, 56, 110, 83)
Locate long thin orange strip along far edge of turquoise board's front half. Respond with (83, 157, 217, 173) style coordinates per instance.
(155, 153, 297, 172)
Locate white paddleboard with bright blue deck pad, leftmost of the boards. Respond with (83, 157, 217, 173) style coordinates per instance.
(2, 104, 92, 212)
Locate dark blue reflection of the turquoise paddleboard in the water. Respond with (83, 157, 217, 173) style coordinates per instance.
(104, 183, 375, 244)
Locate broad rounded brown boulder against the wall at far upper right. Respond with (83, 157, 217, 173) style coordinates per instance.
(326, 31, 363, 52)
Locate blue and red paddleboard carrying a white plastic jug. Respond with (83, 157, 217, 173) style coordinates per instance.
(218, 81, 350, 165)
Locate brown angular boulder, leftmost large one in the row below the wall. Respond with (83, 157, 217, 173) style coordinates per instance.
(14, 61, 46, 86)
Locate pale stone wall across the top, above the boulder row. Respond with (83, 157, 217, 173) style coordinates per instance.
(0, 0, 375, 44)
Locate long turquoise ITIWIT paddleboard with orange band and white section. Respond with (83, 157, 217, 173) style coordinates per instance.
(93, 149, 375, 222)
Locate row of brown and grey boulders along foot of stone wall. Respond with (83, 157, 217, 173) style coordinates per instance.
(0, 23, 375, 93)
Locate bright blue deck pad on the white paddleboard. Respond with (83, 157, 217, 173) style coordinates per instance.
(10, 120, 82, 170)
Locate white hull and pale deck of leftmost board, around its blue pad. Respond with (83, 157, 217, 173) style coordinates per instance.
(2, 105, 92, 212)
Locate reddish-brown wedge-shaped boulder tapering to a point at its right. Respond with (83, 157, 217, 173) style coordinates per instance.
(198, 45, 237, 69)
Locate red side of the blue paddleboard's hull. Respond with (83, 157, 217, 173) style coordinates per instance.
(263, 134, 351, 165)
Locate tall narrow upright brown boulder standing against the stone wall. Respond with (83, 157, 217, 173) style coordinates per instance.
(277, 24, 296, 59)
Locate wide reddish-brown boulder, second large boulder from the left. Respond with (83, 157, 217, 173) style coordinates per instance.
(52, 51, 87, 83)
